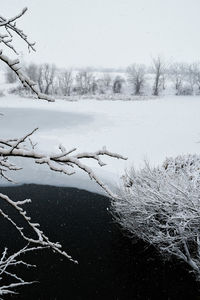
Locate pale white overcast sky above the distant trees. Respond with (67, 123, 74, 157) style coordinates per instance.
(0, 0, 200, 67)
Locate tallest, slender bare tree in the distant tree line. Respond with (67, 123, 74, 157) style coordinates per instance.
(152, 56, 165, 96)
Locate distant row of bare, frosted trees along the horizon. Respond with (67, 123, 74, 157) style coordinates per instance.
(5, 56, 200, 97)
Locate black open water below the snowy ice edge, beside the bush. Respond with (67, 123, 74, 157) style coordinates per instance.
(0, 185, 200, 300)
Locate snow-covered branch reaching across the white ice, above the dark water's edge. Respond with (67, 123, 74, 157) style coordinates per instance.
(0, 128, 126, 198)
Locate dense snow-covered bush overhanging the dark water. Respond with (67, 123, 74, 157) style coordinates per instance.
(112, 155, 200, 279)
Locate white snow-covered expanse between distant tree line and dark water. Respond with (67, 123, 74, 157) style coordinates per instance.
(0, 95, 200, 192)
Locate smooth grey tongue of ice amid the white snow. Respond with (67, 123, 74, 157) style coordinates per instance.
(0, 107, 94, 137)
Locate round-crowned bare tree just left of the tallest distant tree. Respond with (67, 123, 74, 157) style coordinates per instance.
(127, 64, 146, 95)
